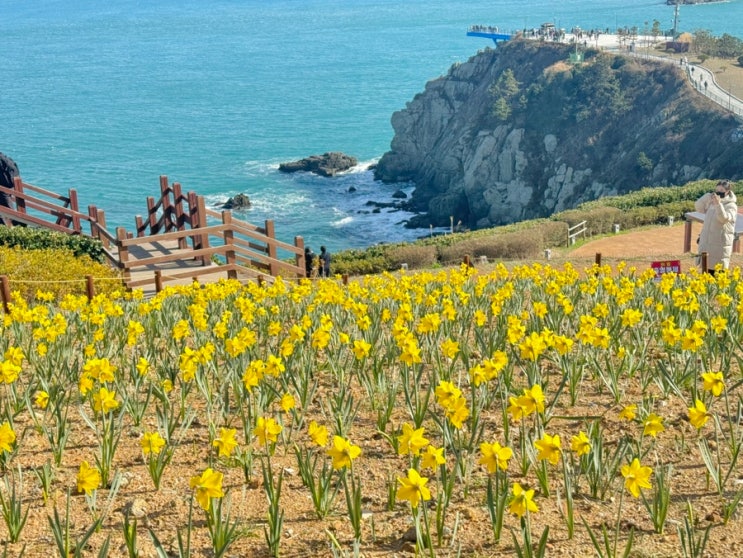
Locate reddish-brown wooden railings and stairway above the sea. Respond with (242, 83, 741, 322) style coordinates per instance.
(0, 176, 305, 291)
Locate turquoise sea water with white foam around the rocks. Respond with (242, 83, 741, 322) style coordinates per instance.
(0, 0, 743, 251)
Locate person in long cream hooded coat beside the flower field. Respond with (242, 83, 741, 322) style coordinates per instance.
(694, 180, 738, 275)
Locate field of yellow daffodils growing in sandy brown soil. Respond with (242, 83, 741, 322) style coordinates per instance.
(0, 264, 743, 558)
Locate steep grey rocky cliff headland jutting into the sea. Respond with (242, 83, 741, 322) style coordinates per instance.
(375, 40, 743, 228)
